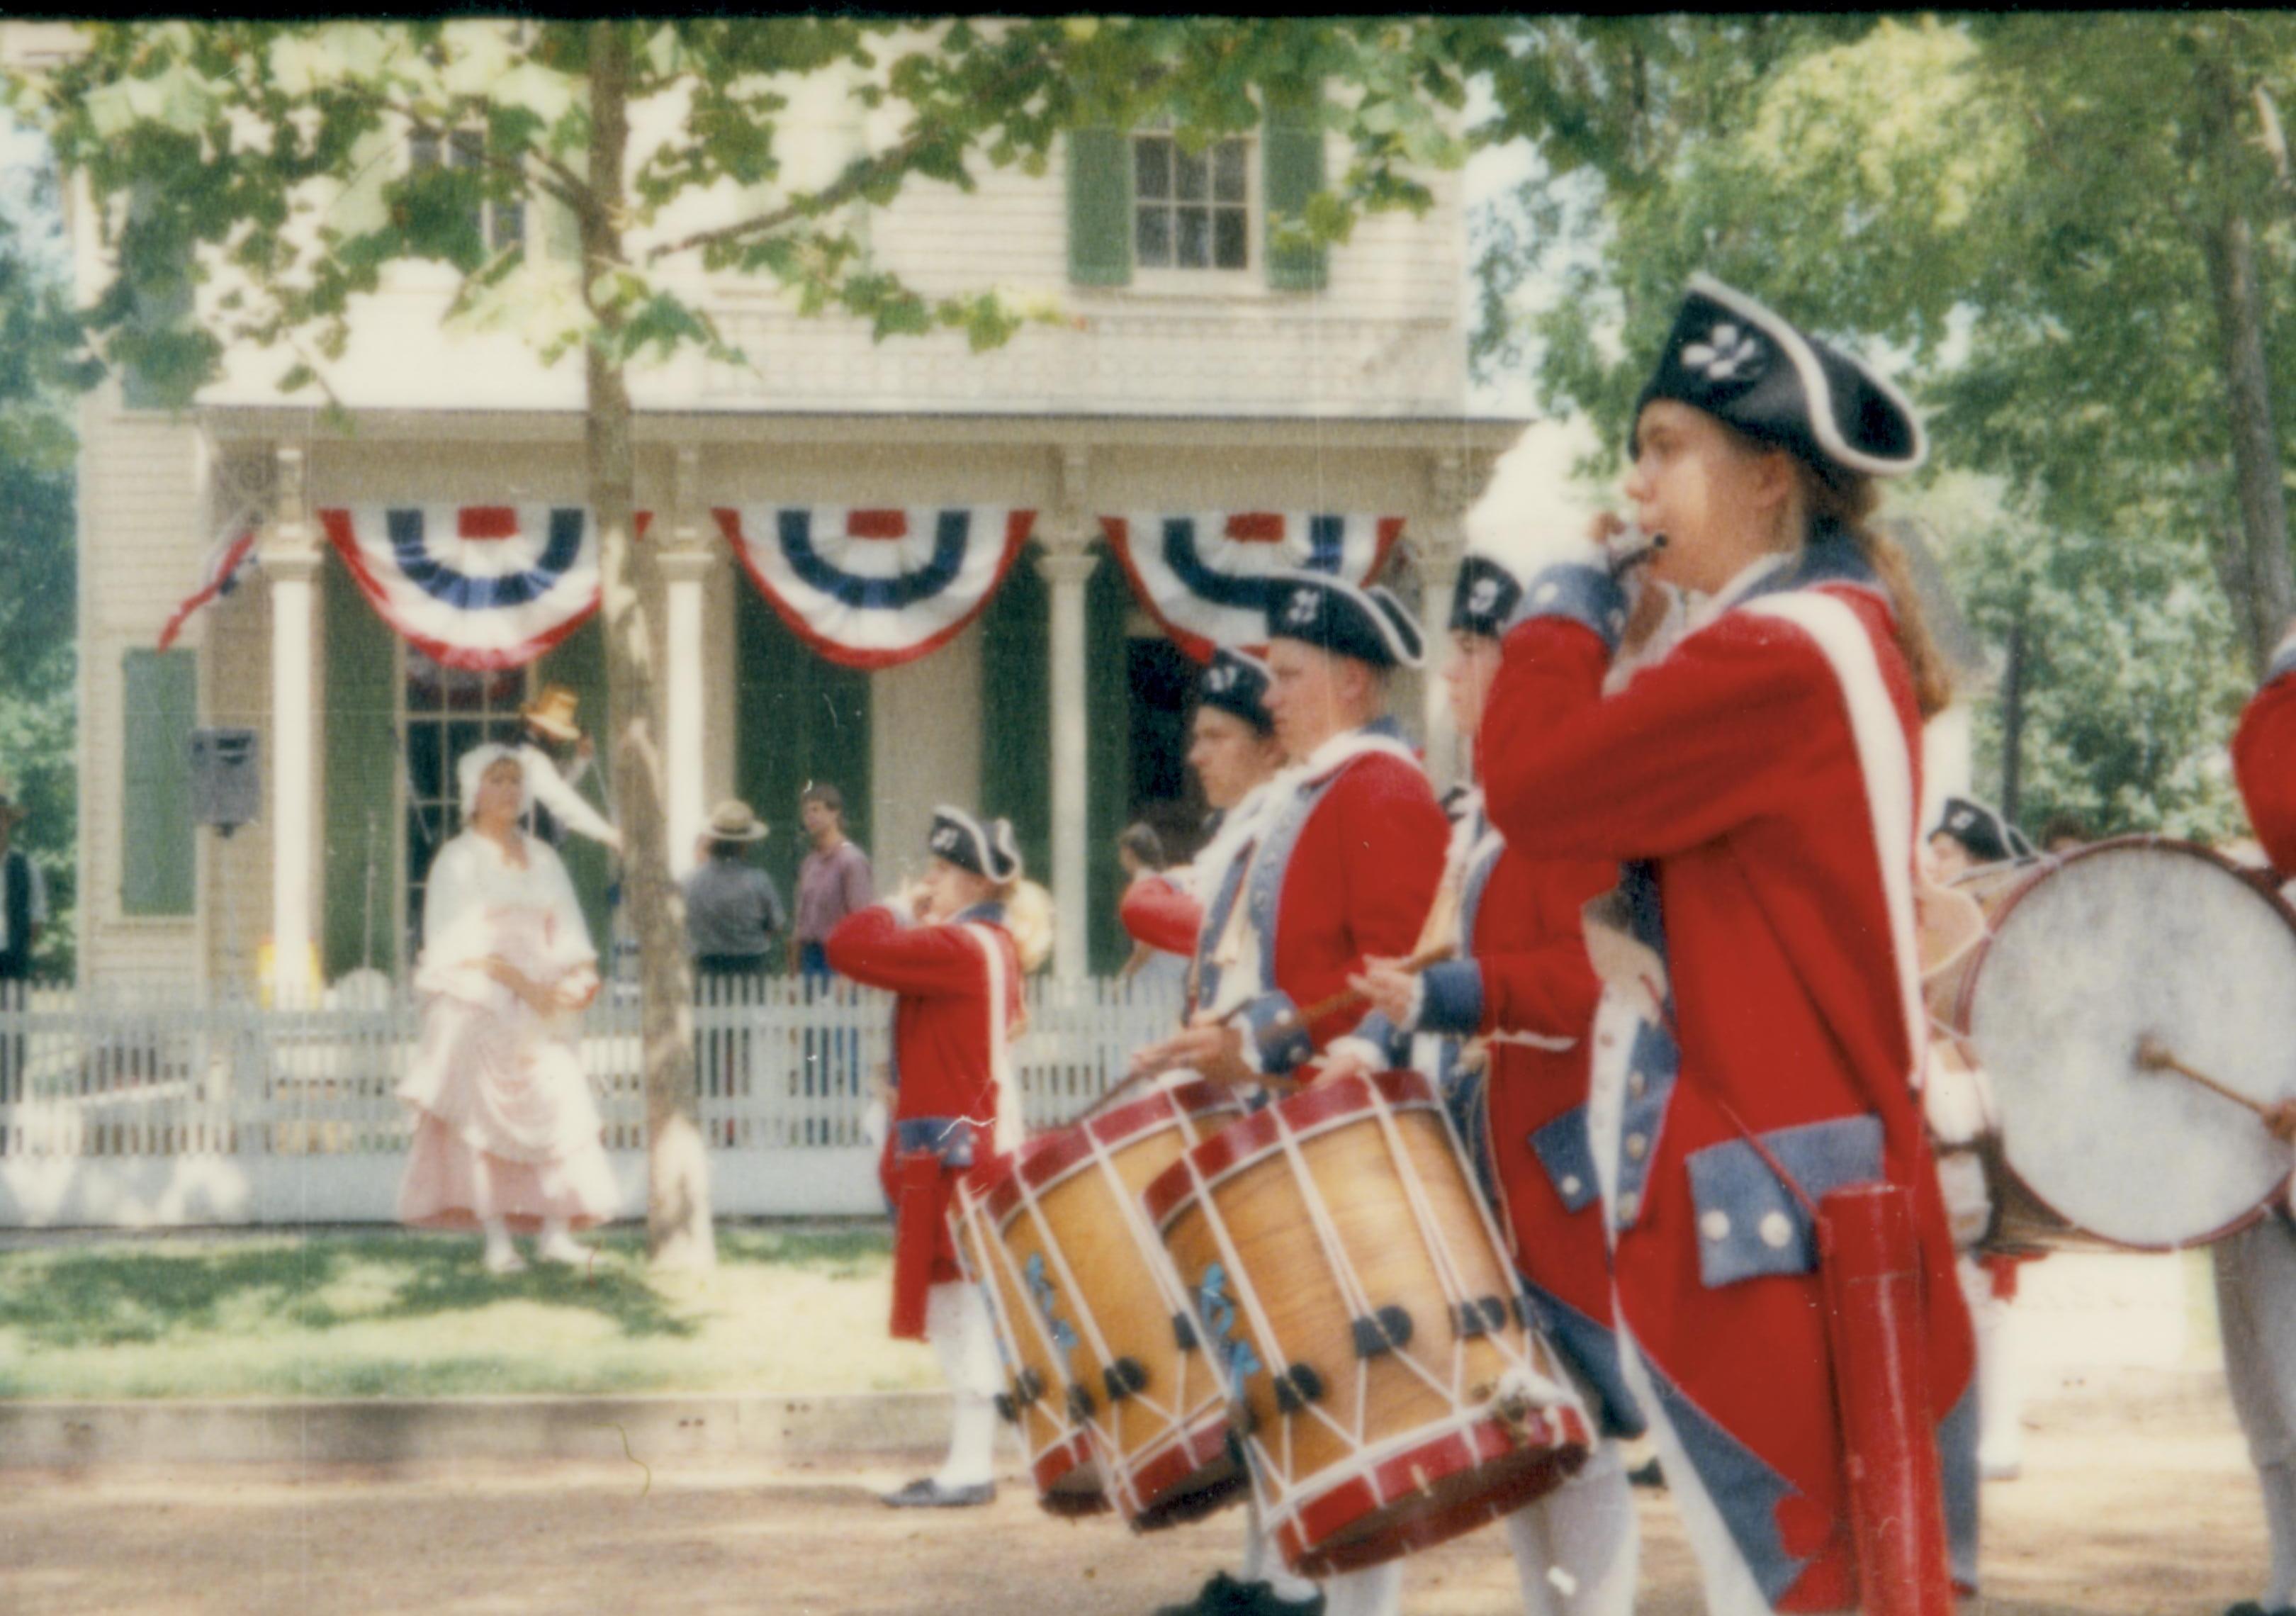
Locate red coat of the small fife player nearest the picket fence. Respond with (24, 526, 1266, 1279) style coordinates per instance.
(822, 904, 1022, 1286)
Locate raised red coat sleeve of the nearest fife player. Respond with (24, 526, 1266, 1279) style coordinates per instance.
(1474, 613, 1839, 858)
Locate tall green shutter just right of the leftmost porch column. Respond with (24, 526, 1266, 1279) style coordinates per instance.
(319, 562, 406, 982)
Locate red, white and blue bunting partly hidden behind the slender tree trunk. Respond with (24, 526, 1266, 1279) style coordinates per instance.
(319, 505, 645, 668)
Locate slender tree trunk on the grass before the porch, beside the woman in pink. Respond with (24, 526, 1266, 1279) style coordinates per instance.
(581, 21, 716, 1269)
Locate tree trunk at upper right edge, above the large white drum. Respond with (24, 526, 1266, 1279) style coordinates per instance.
(2200, 48, 2296, 677)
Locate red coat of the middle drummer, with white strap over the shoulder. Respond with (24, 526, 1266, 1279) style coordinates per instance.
(1230, 728, 1451, 1074)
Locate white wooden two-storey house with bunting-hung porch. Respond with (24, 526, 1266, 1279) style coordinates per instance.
(45, 47, 1520, 984)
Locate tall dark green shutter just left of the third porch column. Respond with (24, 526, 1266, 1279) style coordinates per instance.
(980, 553, 1052, 886)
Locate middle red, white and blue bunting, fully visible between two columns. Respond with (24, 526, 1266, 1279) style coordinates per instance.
(716, 505, 1035, 668)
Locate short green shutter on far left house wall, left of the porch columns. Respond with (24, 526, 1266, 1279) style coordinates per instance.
(119, 652, 200, 916)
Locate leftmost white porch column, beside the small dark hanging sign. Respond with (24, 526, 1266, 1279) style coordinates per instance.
(261, 448, 324, 1006)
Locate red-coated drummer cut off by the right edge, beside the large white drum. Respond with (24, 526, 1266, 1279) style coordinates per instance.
(2213, 624, 2296, 1616)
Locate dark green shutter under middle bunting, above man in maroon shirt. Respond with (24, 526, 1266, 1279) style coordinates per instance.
(733, 580, 867, 918)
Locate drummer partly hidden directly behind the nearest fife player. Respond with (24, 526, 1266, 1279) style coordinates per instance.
(1332, 554, 1662, 1616)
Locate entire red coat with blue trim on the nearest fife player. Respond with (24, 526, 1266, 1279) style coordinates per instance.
(1476, 549, 1974, 1612)
